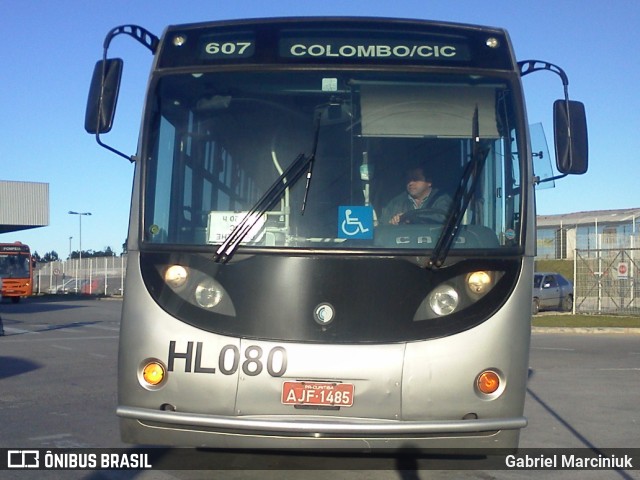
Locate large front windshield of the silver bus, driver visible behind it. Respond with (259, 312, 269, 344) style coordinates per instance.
(143, 69, 522, 254)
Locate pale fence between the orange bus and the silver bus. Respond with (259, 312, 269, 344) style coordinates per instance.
(33, 255, 127, 296)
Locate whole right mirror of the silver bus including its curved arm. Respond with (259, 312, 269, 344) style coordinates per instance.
(518, 60, 589, 176)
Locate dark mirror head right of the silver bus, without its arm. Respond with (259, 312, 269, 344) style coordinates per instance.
(553, 100, 589, 175)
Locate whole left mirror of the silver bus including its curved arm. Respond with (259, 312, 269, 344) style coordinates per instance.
(84, 25, 159, 162)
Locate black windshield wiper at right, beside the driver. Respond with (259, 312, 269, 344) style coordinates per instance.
(427, 105, 489, 268)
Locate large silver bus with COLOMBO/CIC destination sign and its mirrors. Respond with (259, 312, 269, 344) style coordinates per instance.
(85, 17, 587, 451)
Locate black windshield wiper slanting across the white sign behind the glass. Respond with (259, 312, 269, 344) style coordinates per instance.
(213, 153, 313, 263)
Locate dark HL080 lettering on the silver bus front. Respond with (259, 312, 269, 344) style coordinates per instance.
(167, 341, 287, 377)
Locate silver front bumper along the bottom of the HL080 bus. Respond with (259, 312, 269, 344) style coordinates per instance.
(117, 407, 527, 449)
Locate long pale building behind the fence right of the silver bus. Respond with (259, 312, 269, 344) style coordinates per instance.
(537, 208, 640, 259)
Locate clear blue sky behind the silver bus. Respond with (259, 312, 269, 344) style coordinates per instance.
(0, 0, 640, 259)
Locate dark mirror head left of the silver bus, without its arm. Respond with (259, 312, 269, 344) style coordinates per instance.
(84, 58, 124, 134)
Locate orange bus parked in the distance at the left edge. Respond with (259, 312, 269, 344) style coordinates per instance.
(0, 242, 34, 303)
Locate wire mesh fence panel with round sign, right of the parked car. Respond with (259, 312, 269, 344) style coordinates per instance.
(573, 248, 640, 315)
